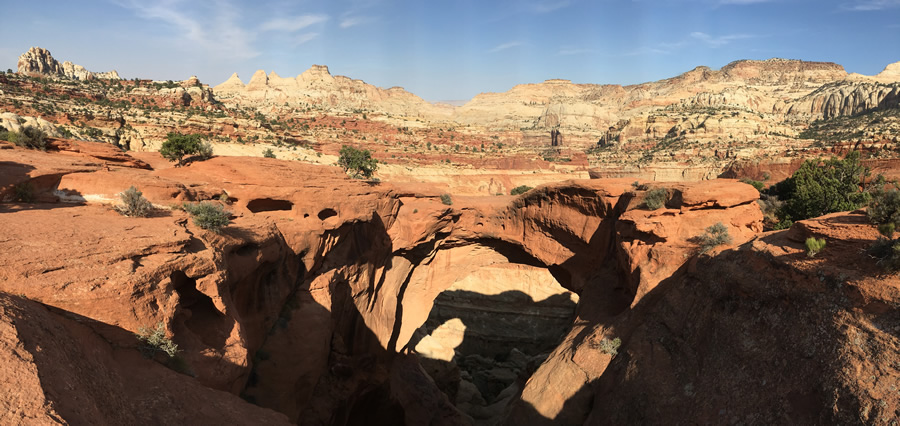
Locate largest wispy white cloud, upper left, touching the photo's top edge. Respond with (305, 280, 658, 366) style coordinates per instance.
(114, 0, 259, 58)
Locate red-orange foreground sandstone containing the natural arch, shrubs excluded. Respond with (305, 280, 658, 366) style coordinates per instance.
(0, 138, 900, 425)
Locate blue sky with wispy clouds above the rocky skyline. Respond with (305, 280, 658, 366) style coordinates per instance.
(0, 0, 900, 101)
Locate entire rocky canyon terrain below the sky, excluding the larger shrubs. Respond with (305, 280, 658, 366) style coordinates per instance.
(0, 48, 900, 425)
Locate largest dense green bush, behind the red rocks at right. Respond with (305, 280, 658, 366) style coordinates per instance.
(767, 151, 869, 221)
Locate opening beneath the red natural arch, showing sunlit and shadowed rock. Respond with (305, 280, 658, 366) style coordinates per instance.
(410, 246, 578, 423)
